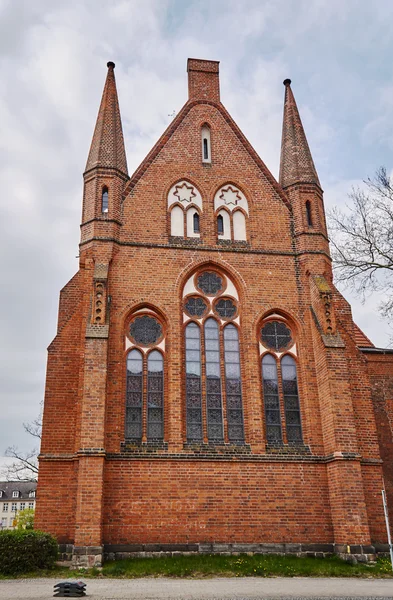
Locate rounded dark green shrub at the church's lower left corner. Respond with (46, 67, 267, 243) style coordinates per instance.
(0, 530, 58, 575)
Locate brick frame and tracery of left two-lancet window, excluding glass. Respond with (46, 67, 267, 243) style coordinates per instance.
(124, 310, 167, 444)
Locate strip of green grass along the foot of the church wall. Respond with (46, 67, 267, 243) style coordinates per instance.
(102, 554, 392, 578)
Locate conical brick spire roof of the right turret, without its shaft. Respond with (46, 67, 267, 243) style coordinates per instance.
(280, 79, 321, 188)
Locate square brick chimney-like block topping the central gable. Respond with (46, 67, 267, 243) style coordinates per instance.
(187, 58, 220, 102)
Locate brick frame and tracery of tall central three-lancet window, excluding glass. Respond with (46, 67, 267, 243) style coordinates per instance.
(183, 268, 245, 444)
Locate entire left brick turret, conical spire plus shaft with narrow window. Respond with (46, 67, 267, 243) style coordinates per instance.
(81, 62, 129, 248)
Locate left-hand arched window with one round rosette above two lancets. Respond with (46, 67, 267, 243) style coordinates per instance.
(125, 314, 165, 442)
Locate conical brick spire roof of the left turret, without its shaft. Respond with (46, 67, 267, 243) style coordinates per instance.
(85, 62, 128, 177)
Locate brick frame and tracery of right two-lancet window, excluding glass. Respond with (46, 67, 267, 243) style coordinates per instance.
(258, 314, 303, 445)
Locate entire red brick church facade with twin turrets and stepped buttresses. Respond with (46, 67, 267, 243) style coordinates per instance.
(36, 59, 393, 564)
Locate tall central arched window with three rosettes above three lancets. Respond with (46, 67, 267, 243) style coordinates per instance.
(183, 270, 244, 443)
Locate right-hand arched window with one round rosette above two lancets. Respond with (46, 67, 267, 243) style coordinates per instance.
(259, 319, 302, 444)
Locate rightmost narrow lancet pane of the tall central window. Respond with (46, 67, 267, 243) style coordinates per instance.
(224, 325, 244, 441)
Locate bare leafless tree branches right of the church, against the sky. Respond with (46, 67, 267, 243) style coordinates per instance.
(328, 167, 393, 321)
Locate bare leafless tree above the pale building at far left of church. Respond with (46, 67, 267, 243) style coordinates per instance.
(1, 414, 42, 481)
